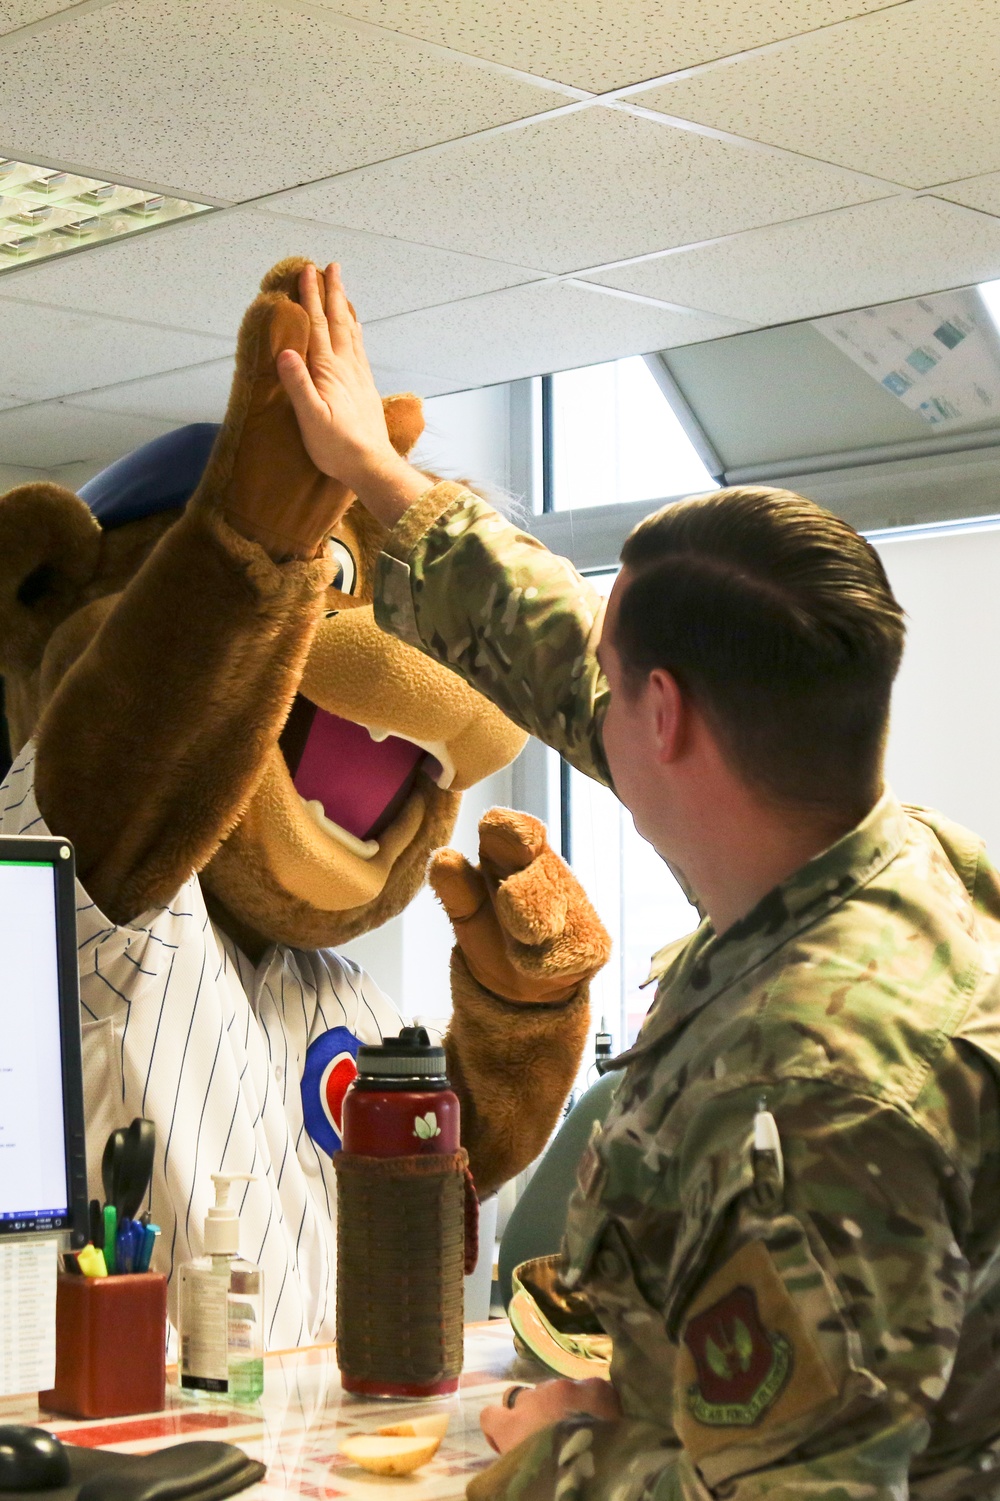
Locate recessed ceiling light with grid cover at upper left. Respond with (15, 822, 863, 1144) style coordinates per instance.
(0, 156, 209, 275)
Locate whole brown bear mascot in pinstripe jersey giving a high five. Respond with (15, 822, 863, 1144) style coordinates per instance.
(0, 260, 608, 1349)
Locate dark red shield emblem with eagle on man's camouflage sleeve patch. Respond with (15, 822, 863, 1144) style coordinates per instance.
(683, 1286, 793, 1427)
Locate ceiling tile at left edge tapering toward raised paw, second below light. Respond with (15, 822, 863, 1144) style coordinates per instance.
(0, 296, 231, 402)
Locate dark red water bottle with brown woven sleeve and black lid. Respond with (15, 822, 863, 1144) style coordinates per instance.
(333, 1027, 477, 1397)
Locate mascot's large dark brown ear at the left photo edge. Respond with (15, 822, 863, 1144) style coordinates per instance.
(0, 483, 101, 672)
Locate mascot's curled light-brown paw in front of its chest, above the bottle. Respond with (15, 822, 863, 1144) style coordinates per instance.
(428, 808, 611, 1004)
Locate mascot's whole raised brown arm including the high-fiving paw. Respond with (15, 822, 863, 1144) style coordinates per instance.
(36, 260, 422, 922)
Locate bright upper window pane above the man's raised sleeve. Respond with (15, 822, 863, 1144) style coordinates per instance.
(548, 356, 718, 510)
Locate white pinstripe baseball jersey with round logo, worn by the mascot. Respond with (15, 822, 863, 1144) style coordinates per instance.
(0, 743, 401, 1349)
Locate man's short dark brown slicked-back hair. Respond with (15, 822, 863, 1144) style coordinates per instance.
(614, 486, 904, 818)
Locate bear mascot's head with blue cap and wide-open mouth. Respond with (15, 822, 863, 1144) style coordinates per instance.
(0, 263, 526, 950)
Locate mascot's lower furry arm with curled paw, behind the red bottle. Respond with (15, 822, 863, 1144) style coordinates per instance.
(429, 808, 611, 1195)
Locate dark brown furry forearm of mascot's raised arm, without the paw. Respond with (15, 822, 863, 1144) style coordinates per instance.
(36, 501, 332, 923)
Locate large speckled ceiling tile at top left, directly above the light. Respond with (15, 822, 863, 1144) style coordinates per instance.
(0, 0, 565, 200)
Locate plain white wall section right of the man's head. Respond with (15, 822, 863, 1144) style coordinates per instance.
(877, 527, 1000, 859)
